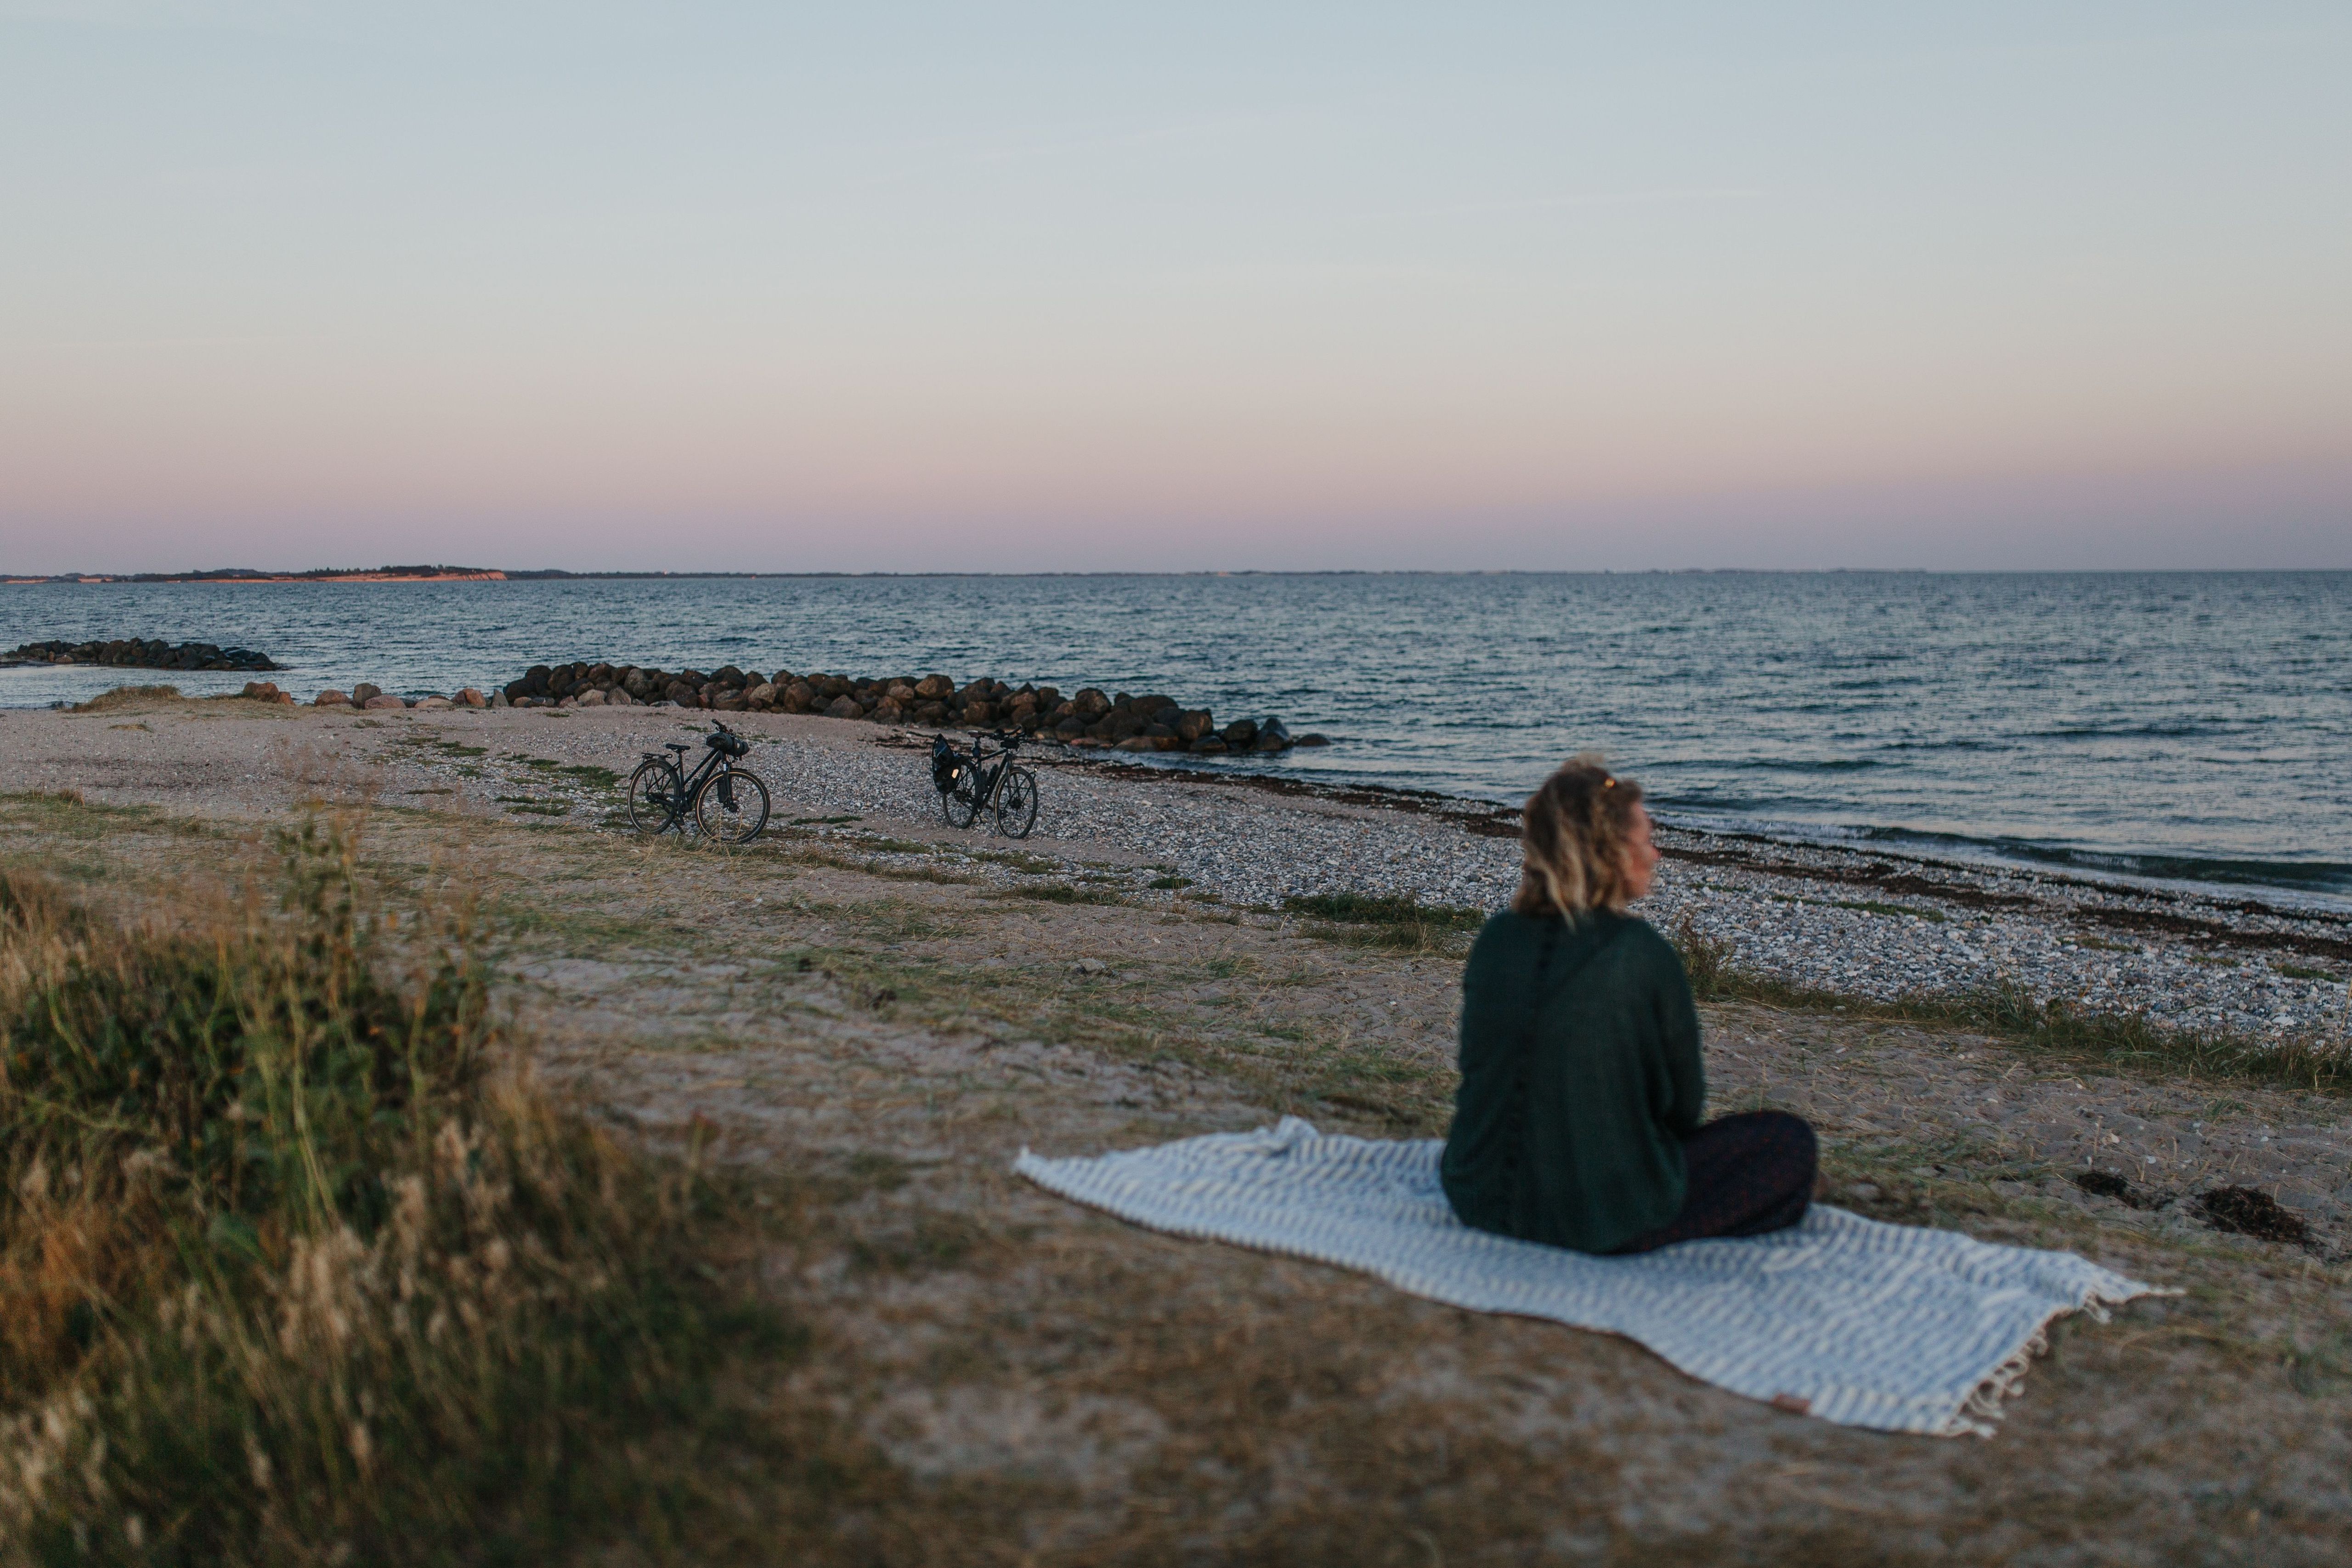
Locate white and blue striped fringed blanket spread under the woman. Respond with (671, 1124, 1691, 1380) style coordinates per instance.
(1014, 1117, 2157, 1436)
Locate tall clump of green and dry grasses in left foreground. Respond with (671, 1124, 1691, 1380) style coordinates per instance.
(0, 821, 779, 1563)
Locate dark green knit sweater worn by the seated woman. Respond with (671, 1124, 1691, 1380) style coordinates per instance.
(1442, 910, 1707, 1253)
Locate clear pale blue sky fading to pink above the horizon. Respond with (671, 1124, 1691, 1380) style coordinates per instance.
(0, 0, 2352, 571)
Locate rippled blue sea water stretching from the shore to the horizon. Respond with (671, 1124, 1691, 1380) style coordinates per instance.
(0, 571, 2352, 903)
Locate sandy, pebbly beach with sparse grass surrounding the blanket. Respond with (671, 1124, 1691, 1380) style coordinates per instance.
(0, 701, 2352, 1563)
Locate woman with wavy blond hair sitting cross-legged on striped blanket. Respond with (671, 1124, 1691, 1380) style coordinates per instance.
(1442, 755, 1814, 1253)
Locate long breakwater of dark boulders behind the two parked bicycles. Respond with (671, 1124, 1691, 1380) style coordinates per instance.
(494, 663, 1329, 757)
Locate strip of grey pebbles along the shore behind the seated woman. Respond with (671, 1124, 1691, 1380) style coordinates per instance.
(14, 703, 2352, 1051)
